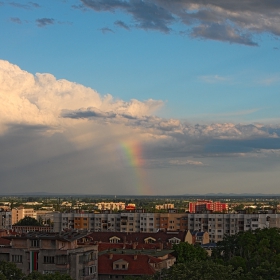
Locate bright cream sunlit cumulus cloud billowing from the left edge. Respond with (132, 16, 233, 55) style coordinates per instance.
(0, 60, 163, 136)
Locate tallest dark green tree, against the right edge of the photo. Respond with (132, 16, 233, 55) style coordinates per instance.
(212, 228, 280, 279)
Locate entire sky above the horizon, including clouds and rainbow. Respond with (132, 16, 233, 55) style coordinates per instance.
(0, 0, 280, 195)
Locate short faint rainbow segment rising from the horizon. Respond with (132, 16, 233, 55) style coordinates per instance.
(120, 142, 152, 195)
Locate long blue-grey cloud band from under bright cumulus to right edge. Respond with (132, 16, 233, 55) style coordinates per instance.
(61, 105, 280, 159)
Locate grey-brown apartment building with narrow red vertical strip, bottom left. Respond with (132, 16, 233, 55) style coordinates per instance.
(0, 231, 98, 280)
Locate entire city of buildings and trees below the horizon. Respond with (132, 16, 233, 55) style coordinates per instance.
(0, 195, 280, 280)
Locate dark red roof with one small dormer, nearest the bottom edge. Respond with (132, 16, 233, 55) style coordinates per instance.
(98, 254, 156, 275)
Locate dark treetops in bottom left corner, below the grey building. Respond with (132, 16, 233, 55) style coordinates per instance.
(0, 261, 72, 280)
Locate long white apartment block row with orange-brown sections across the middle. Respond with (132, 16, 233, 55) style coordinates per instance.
(54, 210, 280, 242)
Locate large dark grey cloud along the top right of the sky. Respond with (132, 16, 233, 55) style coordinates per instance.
(80, 0, 280, 46)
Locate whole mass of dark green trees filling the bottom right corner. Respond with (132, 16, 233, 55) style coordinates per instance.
(127, 228, 280, 280)
